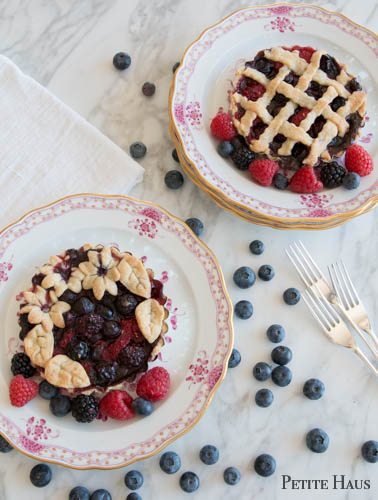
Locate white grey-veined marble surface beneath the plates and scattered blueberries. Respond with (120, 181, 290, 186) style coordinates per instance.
(0, 0, 378, 500)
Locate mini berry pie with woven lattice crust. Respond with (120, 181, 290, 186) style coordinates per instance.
(230, 46, 366, 169)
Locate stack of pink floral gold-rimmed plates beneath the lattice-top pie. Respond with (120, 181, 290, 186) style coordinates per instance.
(169, 4, 378, 229)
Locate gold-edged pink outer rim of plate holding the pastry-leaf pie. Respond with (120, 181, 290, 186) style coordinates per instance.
(0, 193, 234, 470)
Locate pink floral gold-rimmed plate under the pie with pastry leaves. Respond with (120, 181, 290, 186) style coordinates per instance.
(0, 194, 233, 469)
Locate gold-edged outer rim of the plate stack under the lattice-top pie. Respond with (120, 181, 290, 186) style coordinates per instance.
(168, 2, 378, 229)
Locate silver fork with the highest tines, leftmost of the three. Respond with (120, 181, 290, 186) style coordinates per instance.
(286, 241, 378, 360)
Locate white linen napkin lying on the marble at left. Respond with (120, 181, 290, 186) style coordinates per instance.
(0, 55, 144, 229)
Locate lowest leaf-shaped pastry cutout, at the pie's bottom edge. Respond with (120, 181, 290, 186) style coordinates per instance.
(45, 354, 91, 389)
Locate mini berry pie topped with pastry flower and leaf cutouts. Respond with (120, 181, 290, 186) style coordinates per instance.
(12, 244, 168, 395)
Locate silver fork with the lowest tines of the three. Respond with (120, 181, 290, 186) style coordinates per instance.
(303, 289, 378, 377)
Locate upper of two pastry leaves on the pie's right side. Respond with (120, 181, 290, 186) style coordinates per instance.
(118, 255, 151, 299)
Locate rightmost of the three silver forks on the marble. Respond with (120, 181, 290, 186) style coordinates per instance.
(328, 260, 378, 348)
